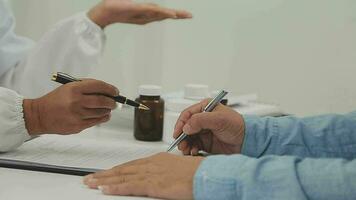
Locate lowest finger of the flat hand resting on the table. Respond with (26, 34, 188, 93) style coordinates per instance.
(99, 180, 148, 196)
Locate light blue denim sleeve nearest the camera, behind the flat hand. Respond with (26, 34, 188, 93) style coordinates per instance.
(193, 155, 356, 200)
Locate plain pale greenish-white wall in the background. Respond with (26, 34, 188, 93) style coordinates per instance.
(11, 0, 356, 115)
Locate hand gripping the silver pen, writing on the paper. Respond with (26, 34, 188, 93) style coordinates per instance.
(167, 90, 245, 155)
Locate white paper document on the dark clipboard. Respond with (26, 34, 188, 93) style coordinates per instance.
(0, 135, 167, 169)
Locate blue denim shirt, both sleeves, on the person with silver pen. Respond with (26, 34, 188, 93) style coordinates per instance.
(193, 112, 356, 200)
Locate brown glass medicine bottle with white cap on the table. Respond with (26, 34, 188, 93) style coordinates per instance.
(134, 85, 164, 141)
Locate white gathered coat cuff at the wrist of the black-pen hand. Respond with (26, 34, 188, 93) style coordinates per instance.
(0, 87, 30, 152)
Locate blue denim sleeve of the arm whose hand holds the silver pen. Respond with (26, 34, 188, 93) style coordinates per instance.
(241, 112, 356, 159)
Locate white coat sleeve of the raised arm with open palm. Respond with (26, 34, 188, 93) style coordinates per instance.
(0, 13, 105, 98)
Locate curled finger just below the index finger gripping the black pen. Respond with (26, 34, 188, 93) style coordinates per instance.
(83, 95, 117, 110)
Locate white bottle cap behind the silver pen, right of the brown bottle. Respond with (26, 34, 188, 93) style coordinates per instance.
(184, 84, 210, 100)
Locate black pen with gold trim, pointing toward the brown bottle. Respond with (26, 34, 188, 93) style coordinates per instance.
(52, 72, 149, 110)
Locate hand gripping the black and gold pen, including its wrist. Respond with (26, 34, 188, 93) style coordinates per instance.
(23, 79, 119, 135)
